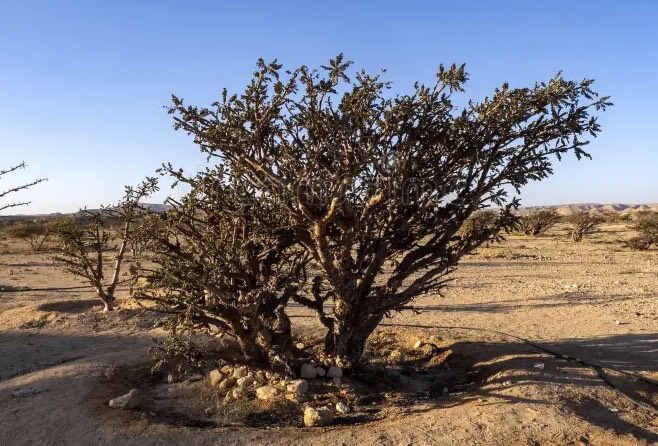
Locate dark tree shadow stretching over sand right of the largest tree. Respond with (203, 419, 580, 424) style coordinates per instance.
(376, 324, 658, 444)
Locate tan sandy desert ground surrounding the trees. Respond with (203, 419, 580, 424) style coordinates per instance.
(0, 225, 658, 445)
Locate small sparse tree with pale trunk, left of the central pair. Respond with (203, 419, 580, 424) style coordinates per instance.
(55, 178, 157, 311)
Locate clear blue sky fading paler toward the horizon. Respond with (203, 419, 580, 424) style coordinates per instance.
(0, 0, 658, 213)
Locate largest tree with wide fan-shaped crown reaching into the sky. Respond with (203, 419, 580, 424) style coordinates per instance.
(165, 55, 610, 367)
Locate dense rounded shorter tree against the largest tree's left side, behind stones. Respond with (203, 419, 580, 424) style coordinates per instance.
(133, 166, 309, 373)
